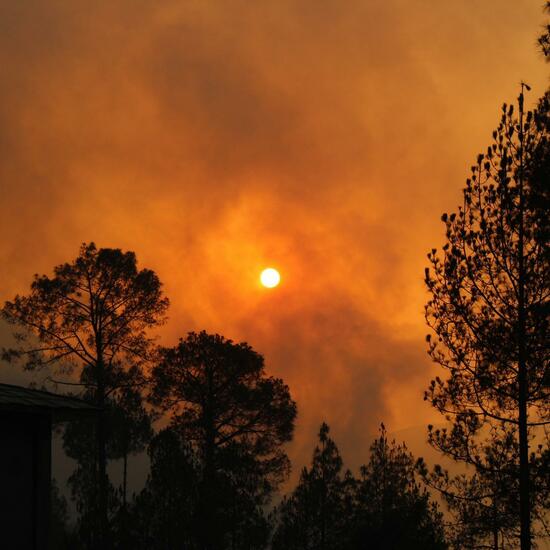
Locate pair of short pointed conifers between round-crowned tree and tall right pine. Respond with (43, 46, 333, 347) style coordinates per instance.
(272, 424, 447, 550)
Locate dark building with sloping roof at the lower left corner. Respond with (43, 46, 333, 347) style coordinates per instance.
(0, 384, 97, 550)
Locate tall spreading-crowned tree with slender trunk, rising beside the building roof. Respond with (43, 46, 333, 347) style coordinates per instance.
(2, 243, 168, 548)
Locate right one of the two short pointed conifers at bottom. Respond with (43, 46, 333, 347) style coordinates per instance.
(349, 424, 447, 550)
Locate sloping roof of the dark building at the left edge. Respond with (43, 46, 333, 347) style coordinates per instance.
(0, 384, 99, 416)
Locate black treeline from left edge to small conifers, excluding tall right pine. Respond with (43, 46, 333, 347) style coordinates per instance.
(3, 238, 443, 550)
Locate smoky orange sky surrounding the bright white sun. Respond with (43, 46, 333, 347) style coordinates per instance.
(0, 0, 548, 474)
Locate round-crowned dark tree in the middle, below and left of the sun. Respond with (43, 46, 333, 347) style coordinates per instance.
(152, 332, 296, 550)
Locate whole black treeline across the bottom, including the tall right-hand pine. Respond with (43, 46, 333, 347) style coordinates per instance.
(2, 178, 550, 550)
